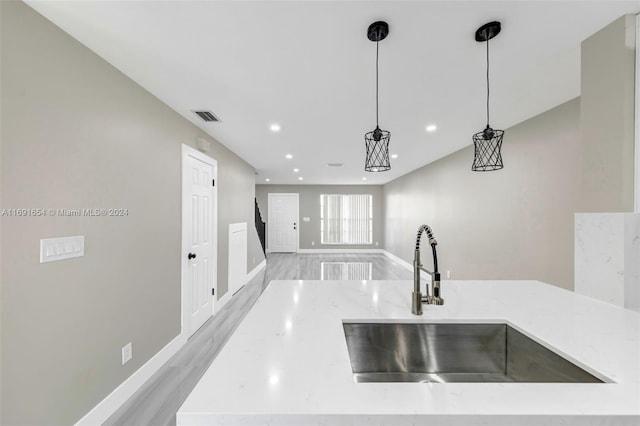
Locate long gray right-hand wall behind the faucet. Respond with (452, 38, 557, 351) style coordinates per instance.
(383, 98, 580, 292)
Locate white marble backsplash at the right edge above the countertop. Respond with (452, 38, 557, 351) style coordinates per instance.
(575, 213, 640, 311)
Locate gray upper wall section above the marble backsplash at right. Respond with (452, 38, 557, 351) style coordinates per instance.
(580, 15, 636, 212)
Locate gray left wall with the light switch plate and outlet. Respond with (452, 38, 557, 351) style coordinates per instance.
(0, 1, 262, 425)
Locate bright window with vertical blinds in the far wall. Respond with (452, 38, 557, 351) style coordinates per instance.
(320, 194, 373, 244)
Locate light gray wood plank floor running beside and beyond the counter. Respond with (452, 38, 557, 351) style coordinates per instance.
(105, 253, 412, 426)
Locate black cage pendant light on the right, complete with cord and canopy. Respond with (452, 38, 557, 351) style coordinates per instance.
(471, 21, 504, 172)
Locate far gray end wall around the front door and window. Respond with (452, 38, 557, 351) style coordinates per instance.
(256, 185, 384, 249)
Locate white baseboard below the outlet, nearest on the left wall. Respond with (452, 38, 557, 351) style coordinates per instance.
(76, 334, 187, 425)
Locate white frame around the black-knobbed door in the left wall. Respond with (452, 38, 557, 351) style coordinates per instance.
(180, 144, 219, 339)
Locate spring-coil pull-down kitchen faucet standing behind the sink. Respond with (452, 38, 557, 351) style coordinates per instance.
(411, 225, 444, 315)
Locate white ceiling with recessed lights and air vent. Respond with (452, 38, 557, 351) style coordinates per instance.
(27, 0, 640, 184)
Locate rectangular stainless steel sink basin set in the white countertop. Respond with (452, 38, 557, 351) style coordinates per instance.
(343, 322, 603, 383)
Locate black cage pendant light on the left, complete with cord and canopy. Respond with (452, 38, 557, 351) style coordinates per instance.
(364, 21, 391, 172)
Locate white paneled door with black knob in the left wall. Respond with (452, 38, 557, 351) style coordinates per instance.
(182, 145, 217, 336)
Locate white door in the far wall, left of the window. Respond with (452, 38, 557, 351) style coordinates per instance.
(268, 194, 298, 253)
